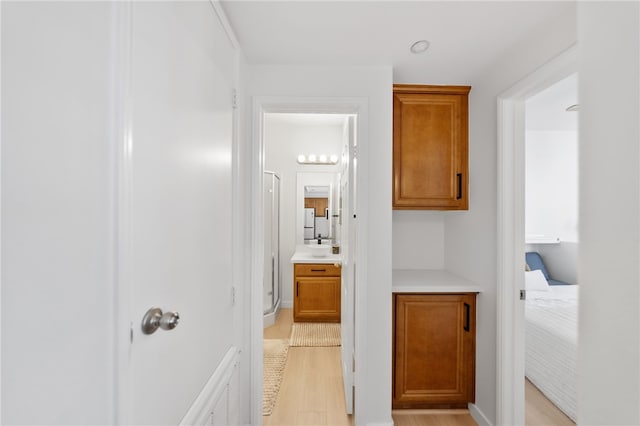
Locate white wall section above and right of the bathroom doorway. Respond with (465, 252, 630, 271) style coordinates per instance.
(247, 66, 392, 425)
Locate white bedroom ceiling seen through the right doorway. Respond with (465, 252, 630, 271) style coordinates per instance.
(525, 74, 578, 132)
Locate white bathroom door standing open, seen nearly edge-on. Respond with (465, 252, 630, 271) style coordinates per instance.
(340, 117, 358, 414)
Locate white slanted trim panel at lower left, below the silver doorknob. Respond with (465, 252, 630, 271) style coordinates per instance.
(179, 346, 239, 426)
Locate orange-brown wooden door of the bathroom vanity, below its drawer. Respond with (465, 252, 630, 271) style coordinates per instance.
(293, 277, 340, 322)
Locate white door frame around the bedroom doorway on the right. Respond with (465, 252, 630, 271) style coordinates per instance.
(496, 45, 578, 425)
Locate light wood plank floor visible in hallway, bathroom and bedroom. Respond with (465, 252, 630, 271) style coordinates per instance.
(262, 308, 574, 426)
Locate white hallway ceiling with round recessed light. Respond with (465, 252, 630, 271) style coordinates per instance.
(222, 0, 575, 84)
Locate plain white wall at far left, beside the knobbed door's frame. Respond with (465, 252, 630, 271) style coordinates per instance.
(2, 2, 115, 424)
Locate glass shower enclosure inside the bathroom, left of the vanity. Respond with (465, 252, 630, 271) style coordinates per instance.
(263, 171, 282, 327)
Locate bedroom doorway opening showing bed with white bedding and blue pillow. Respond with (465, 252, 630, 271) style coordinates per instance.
(524, 73, 579, 426)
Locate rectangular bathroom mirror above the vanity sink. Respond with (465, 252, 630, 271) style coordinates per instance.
(296, 172, 340, 244)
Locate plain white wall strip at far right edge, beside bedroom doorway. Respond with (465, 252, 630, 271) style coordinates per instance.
(578, 2, 640, 425)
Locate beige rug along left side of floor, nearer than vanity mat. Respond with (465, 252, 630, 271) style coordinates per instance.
(262, 339, 289, 416)
